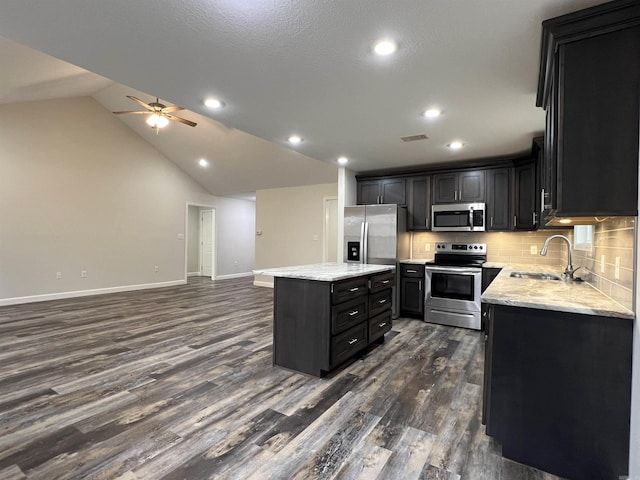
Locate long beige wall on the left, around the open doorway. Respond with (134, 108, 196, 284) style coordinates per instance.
(0, 97, 255, 304)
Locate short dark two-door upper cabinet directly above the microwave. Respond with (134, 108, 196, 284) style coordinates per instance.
(433, 170, 485, 203)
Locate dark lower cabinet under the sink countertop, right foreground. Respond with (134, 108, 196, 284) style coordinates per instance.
(483, 304, 633, 480)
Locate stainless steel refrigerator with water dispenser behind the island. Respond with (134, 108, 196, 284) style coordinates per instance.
(344, 204, 410, 318)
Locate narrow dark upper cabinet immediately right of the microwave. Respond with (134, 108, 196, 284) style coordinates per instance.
(485, 168, 513, 231)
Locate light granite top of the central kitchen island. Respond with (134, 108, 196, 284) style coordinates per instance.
(253, 263, 396, 282)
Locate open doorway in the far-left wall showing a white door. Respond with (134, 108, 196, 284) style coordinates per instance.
(185, 204, 216, 280)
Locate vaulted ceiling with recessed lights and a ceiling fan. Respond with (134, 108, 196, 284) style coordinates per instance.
(0, 0, 603, 196)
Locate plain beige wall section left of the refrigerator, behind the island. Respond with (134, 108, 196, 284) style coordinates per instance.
(255, 183, 338, 284)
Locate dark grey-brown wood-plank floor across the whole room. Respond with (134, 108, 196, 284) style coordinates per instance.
(0, 277, 556, 480)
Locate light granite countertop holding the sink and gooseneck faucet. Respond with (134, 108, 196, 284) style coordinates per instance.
(482, 263, 634, 319)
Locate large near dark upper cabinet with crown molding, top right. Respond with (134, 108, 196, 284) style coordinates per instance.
(536, 0, 640, 216)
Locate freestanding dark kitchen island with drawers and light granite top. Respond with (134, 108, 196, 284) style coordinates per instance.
(253, 263, 395, 377)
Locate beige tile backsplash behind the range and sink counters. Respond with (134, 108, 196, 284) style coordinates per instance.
(411, 217, 636, 309)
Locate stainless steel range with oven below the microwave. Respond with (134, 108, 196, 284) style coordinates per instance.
(424, 243, 487, 330)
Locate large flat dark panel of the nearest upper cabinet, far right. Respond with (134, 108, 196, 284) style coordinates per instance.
(557, 27, 640, 216)
